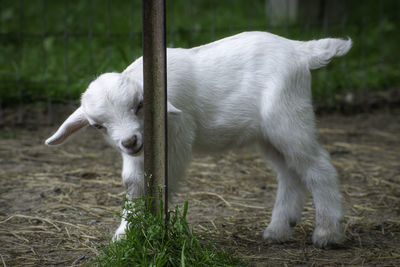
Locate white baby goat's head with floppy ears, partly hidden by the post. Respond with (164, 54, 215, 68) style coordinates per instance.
(46, 73, 180, 155)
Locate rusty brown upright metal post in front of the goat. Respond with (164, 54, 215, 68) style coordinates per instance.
(142, 0, 168, 217)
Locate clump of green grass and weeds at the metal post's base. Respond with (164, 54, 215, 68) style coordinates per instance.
(91, 198, 247, 267)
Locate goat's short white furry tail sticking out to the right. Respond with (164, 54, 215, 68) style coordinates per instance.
(296, 38, 352, 70)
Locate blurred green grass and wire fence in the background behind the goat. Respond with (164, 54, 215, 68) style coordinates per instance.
(0, 0, 400, 124)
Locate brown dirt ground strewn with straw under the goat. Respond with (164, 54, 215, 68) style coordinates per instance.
(0, 108, 400, 266)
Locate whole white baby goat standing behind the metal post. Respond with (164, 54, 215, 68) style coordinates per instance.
(46, 32, 352, 249)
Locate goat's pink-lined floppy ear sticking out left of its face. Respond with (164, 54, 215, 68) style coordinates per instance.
(45, 107, 89, 146)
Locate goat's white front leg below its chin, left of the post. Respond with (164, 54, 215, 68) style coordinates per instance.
(113, 152, 144, 241)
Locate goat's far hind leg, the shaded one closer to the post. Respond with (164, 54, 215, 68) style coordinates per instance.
(263, 150, 306, 242)
